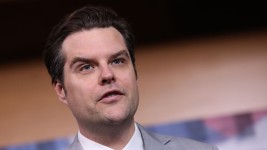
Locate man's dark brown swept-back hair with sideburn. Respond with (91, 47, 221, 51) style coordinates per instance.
(44, 6, 136, 85)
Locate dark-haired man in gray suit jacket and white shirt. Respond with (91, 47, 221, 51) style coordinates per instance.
(44, 6, 220, 150)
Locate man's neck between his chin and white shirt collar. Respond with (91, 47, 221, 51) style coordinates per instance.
(79, 120, 135, 149)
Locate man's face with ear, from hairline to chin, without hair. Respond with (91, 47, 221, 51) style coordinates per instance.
(54, 27, 139, 126)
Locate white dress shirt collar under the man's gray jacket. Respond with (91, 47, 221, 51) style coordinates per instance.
(78, 124, 144, 150)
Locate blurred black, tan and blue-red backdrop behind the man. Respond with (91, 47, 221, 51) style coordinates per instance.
(0, 0, 267, 150)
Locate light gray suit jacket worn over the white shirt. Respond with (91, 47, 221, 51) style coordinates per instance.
(68, 125, 218, 150)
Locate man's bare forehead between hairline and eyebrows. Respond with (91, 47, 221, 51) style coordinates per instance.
(62, 27, 127, 59)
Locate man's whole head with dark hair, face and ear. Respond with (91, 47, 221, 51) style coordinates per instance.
(44, 7, 139, 133)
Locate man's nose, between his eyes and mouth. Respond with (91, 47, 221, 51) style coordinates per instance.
(99, 65, 115, 85)
